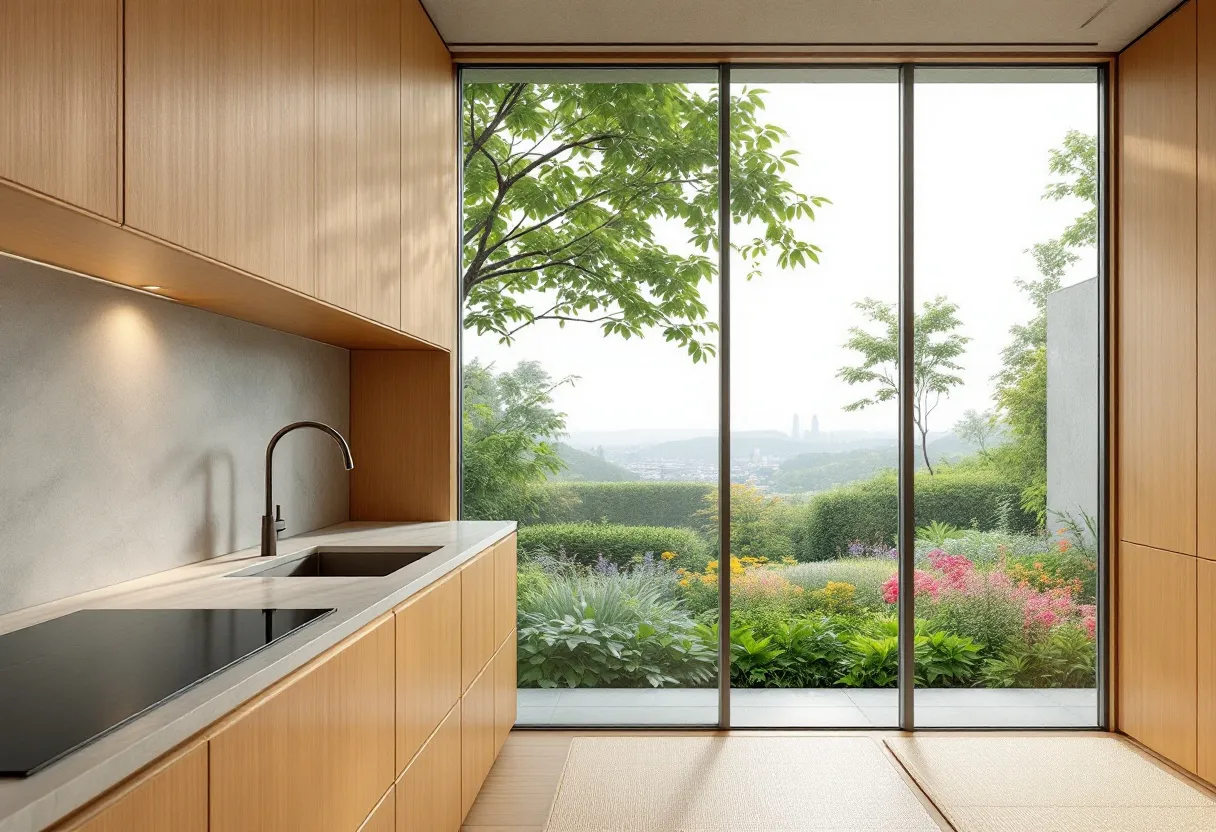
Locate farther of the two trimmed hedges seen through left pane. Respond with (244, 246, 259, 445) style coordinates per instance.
(535, 482, 715, 528)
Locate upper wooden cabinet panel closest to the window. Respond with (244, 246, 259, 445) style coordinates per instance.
(401, 0, 458, 349)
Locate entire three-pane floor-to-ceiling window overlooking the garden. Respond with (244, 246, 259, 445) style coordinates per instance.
(461, 66, 1104, 727)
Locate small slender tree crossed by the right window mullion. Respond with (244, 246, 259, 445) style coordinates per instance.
(837, 294, 970, 474)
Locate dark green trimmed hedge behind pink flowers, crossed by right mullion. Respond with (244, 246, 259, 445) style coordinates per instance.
(795, 470, 1038, 561)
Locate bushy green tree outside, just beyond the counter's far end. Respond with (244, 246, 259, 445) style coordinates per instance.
(463, 360, 575, 519)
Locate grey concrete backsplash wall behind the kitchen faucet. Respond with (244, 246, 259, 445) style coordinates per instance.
(0, 257, 358, 613)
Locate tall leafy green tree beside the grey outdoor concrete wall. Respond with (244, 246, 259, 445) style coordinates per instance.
(992, 130, 1098, 523)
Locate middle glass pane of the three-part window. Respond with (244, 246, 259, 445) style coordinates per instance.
(731, 68, 900, 727)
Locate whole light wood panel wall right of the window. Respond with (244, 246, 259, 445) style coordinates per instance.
(1115, 0, 1216, 782)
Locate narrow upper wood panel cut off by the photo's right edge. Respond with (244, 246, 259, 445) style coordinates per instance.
(1196, 0, 1216, 558)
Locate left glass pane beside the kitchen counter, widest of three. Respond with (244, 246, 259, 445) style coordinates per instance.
(462, 69, 719, 726)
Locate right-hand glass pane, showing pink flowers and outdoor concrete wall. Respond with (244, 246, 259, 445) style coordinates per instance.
(916, 68, 1100, 727)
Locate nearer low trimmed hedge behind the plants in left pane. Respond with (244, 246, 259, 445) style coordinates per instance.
(518, 523, 709, 570)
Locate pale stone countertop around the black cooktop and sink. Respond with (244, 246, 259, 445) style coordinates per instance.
(0, 521, 516, 832)
